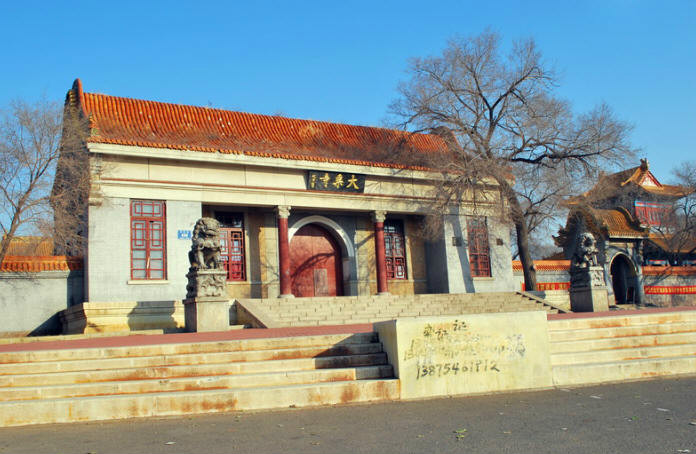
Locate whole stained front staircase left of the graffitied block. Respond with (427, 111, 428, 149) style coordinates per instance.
(0, 332, 399, 426)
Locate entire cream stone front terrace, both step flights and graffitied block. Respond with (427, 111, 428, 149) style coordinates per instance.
(0, 308, 696, 426)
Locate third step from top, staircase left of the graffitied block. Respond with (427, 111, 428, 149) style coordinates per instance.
(0, 353, 387, 388)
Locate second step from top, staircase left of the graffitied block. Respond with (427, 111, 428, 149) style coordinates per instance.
(0, 342, 382, 376)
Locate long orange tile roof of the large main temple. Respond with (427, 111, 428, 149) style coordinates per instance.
(68, 79, 446, 169)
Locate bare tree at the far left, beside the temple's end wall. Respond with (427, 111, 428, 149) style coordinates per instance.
(0, 100, 89, 263)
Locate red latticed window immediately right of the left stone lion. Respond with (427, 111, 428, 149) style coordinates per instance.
(220, 212, 246, 281)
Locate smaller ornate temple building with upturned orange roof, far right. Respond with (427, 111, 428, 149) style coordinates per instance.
(555, 159, 696, 304)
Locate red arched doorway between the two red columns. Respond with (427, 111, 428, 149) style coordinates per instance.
(290, 224, 343, 297)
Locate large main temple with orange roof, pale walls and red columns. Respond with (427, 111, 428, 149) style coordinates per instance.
(57, 80, 514, 308)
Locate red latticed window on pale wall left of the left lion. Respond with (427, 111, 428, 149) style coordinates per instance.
(131, 200, 167, 279)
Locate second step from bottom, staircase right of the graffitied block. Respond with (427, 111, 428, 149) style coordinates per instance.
(551, 343, 696, 367)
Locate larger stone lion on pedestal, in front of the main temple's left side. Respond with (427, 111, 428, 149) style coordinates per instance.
(184, 218, 230, 332)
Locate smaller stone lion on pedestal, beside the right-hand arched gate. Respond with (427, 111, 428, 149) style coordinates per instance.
(570, 232, 609, 312)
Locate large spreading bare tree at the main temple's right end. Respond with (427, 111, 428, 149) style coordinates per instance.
(390, 32, 633, 289)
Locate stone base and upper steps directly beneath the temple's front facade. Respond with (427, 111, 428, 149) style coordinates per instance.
(60, 292, 565, 334)
